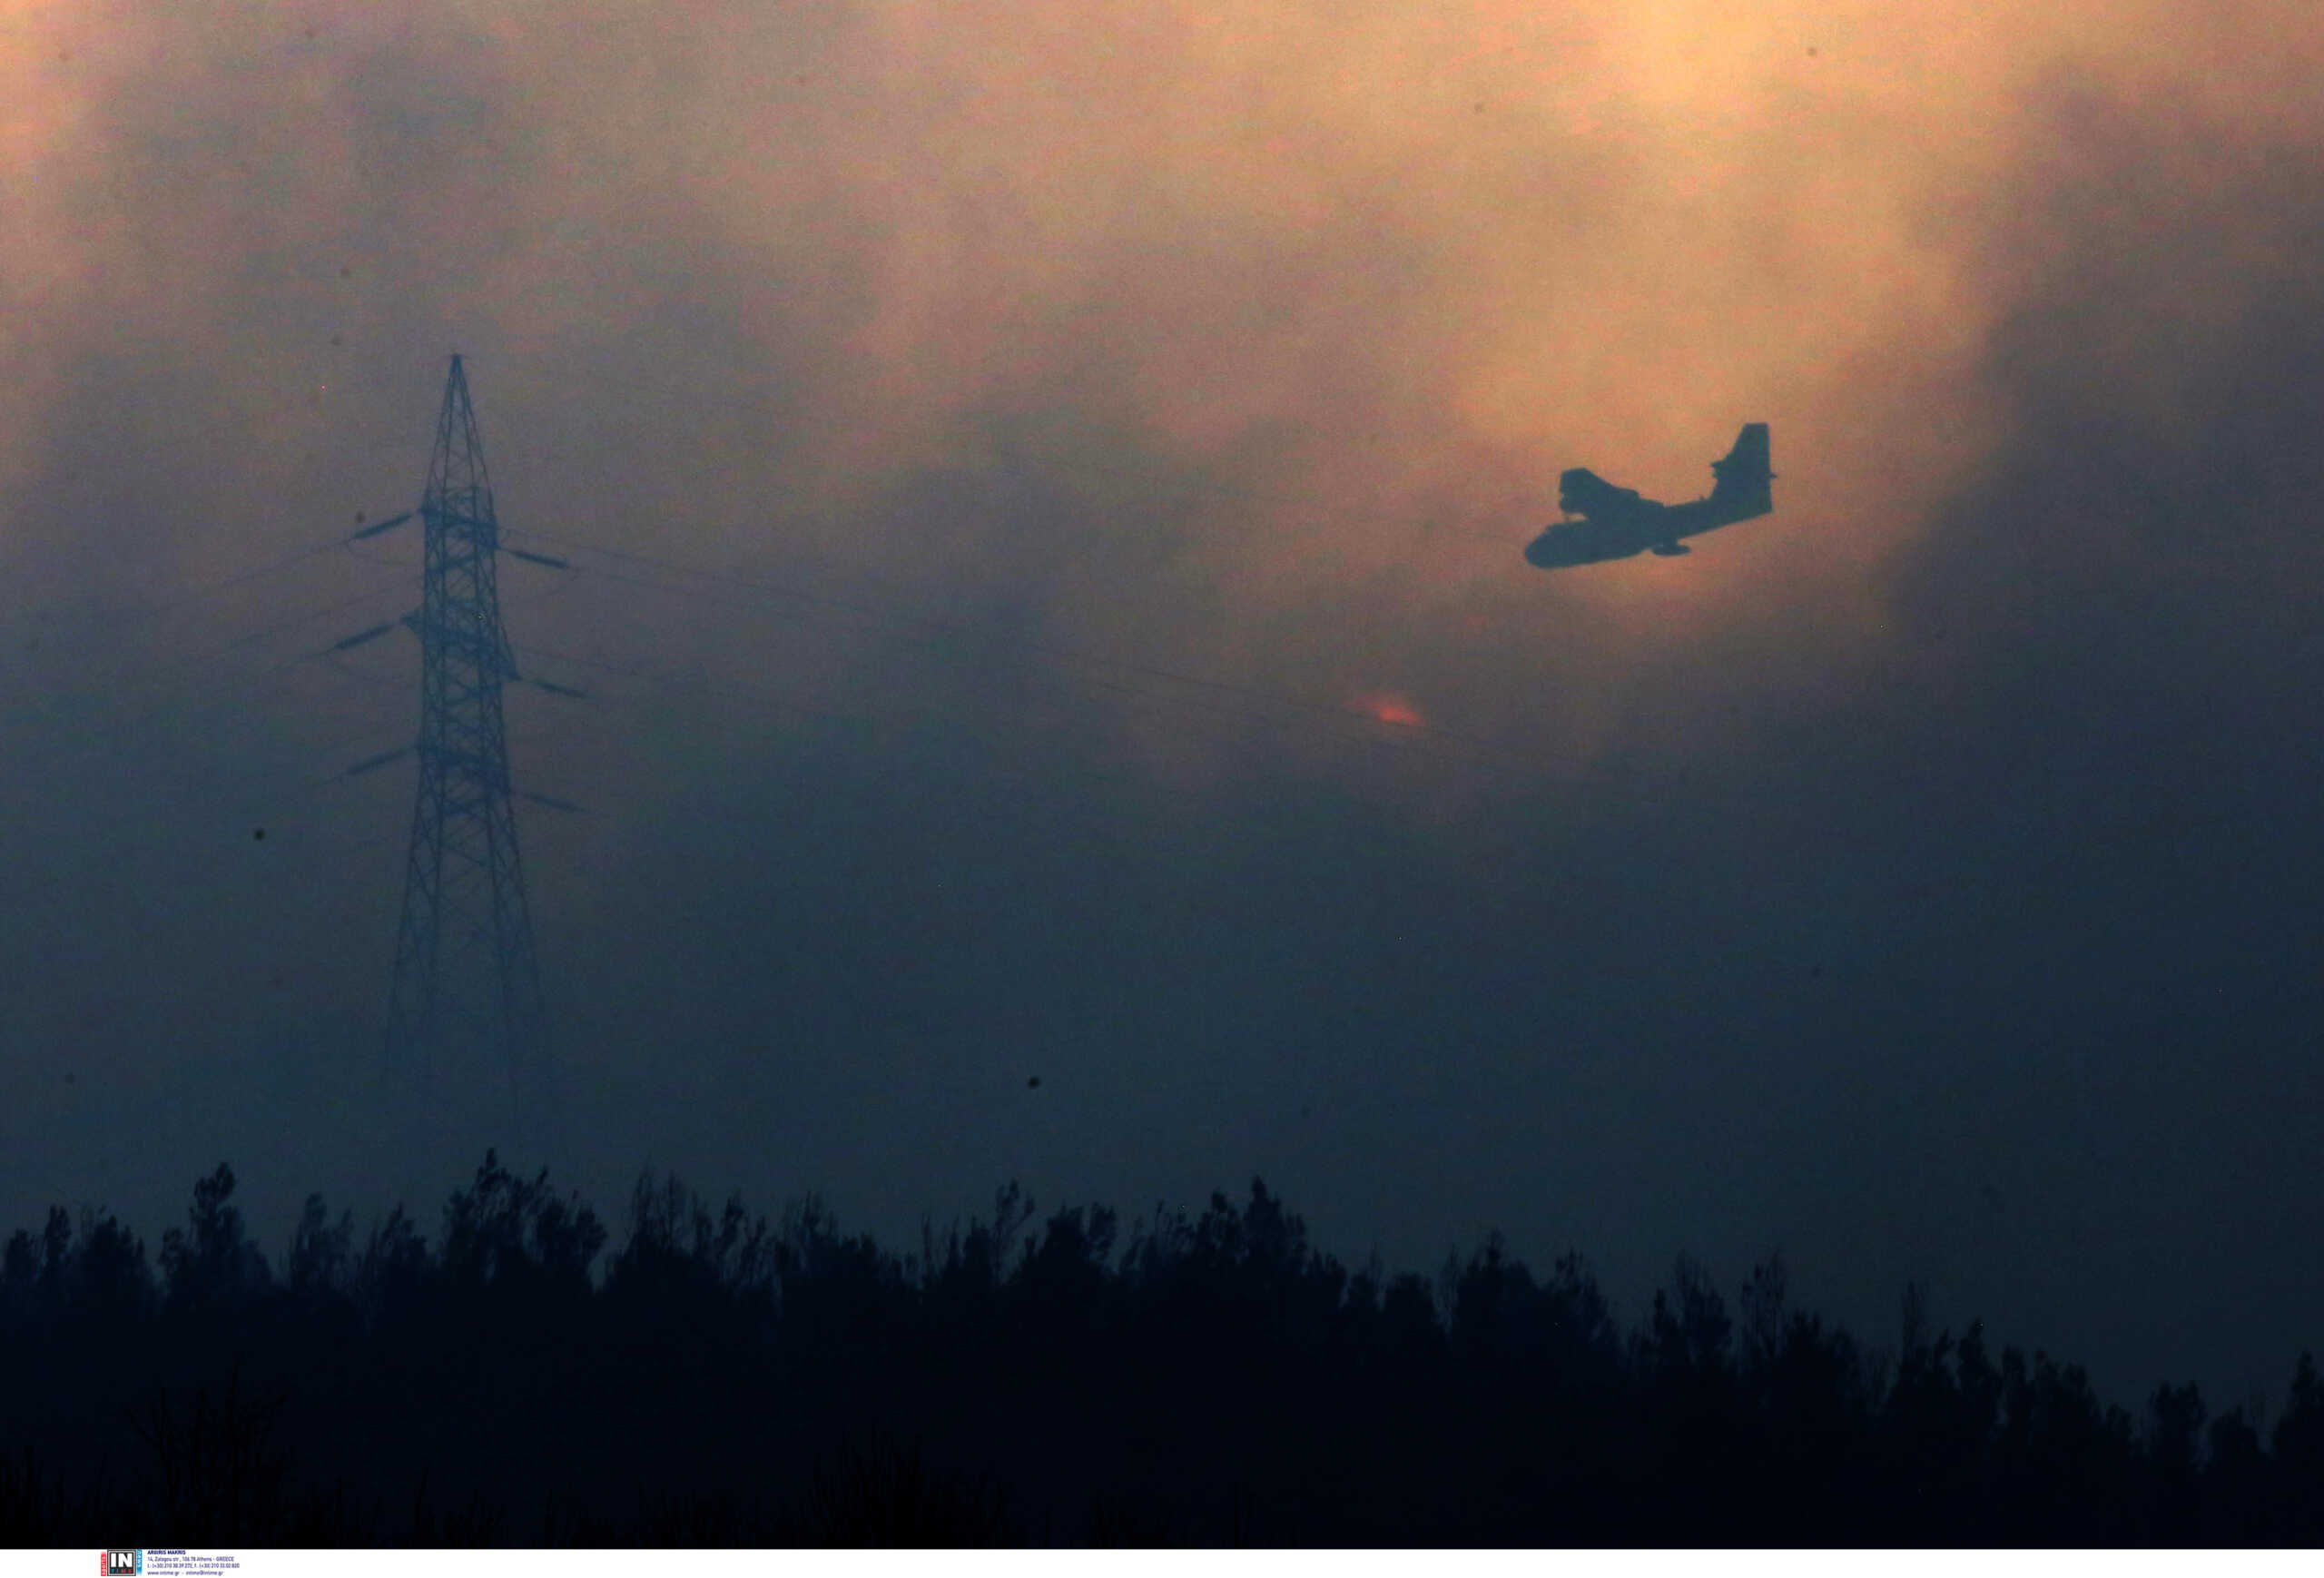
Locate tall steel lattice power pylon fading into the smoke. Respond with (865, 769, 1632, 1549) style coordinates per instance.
(389, 356, 548, 1122)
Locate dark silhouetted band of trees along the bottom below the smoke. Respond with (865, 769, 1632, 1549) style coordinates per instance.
(0, 1158, 2324, 1548)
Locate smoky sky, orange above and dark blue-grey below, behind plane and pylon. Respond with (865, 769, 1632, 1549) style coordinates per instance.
(0, 0, 2324, 1404)
